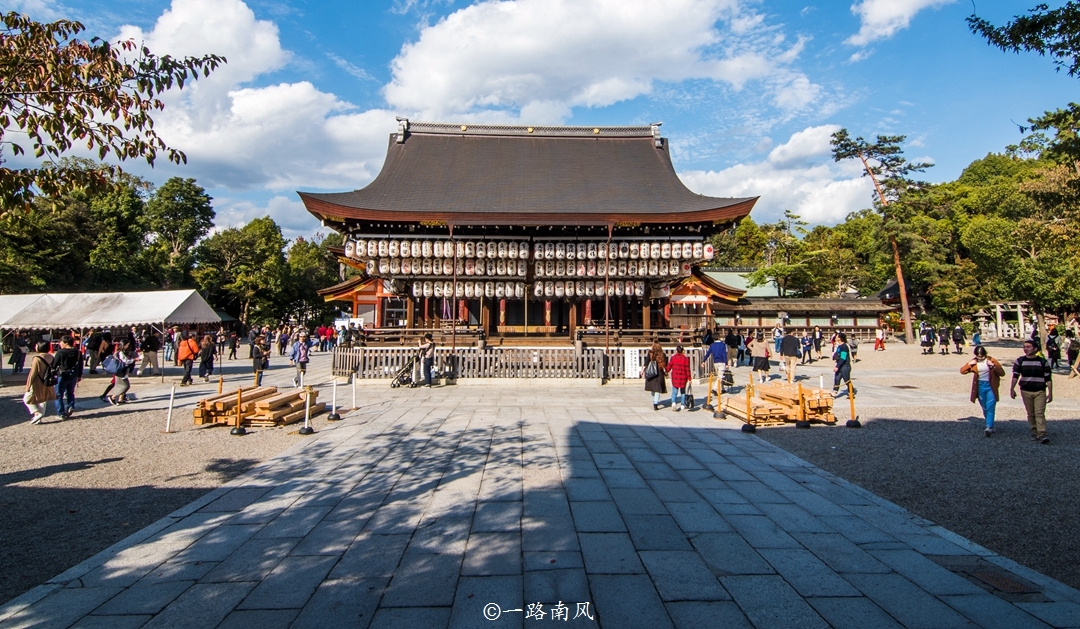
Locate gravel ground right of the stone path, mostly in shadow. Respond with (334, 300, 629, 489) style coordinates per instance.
(758, 344, 1080, 588)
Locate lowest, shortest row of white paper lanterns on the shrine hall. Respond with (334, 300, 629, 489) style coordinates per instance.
(413, 280, 646, 299)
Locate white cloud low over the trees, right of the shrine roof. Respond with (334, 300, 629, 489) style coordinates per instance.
(679, 125, 874, 225)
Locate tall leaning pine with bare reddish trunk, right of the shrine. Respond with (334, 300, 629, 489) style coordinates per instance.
(831, 129, 932, 344)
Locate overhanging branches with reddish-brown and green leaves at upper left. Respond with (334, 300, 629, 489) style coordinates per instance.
(0, 12, 226, 213)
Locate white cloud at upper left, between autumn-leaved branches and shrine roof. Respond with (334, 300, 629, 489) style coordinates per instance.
(109, 0, 396, 194)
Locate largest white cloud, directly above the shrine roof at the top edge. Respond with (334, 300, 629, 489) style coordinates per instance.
(383, 0, 821, 122)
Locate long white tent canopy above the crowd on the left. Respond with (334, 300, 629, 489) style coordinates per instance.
(0, 290, 221, 330)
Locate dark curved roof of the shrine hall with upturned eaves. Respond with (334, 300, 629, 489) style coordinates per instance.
(300, 123, 757, 224)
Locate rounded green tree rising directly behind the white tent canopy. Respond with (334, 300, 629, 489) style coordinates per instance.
(146, 177, 214, 289)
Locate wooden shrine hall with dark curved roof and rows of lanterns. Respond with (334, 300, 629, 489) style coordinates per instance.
(299, 119, 757, 345)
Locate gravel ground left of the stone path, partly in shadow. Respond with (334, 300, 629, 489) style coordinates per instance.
(0, 367, 339, 603)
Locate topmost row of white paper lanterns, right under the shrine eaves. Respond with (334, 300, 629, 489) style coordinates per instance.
(345, 240, 715, 260)
